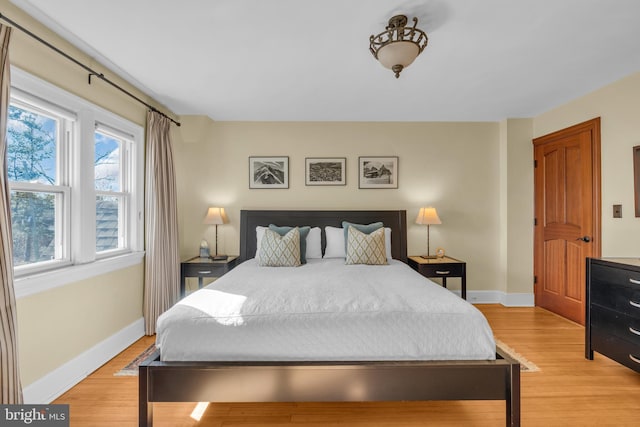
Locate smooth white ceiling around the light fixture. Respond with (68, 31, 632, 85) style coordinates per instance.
(9, 0, 640, 121)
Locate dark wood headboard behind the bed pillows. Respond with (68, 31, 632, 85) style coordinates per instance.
(240, 210, 407, 262)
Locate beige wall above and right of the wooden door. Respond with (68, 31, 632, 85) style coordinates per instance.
(533, 73, 640, 257)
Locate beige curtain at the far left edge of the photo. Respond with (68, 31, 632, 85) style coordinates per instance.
(0, 25, 22, 405)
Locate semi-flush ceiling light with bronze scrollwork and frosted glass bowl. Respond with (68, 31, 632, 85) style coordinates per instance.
(369, 15, 429, 79)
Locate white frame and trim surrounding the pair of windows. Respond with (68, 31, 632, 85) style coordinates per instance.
(10, 66, 145, 298)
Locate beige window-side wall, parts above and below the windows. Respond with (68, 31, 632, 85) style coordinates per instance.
(0, 0, 156, 386)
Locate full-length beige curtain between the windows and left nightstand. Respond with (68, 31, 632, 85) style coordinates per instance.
(144, 111, 180, 335)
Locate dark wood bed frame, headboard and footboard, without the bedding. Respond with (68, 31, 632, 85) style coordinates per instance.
(139, 210, 520, 426)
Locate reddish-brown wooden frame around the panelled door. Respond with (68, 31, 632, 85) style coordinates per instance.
(533, 117, 602, 306)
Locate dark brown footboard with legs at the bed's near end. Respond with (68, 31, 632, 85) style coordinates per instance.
(139, 353, 520, 427)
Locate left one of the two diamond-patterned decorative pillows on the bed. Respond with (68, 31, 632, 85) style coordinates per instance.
(258, 227, 300, 267)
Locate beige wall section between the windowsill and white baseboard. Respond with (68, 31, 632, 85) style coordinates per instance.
(17, 264, 144, 386)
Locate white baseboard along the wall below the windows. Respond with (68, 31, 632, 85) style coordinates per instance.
(22, 318, 144, 404)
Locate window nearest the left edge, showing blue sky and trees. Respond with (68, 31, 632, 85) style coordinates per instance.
(7, 99, 69, 267)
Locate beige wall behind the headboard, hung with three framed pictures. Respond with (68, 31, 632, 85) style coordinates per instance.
(174, 117, 504, 296)
